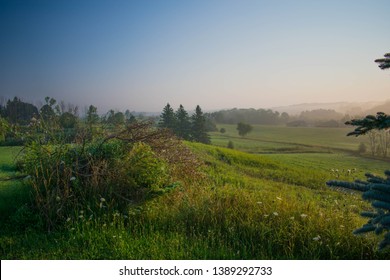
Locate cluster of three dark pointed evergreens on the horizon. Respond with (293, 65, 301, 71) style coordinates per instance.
(158, 103, 212, 144)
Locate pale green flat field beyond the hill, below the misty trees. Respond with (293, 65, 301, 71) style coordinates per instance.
(211, 124, 367, 153)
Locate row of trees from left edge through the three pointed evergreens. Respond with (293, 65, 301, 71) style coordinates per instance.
(0, 97, 216, 145)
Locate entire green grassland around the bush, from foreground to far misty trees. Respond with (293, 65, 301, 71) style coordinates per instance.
(0, 125, 390, 259)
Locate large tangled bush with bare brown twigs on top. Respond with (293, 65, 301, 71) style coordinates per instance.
(19, 123, 200, 229)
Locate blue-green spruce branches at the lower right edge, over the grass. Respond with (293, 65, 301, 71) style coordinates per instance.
(327, 171, 390, 250)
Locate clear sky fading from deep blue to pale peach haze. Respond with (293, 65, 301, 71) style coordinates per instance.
(0, 0, 390, 112)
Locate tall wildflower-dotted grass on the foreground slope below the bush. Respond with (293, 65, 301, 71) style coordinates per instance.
(0, 143, 390, 259)
